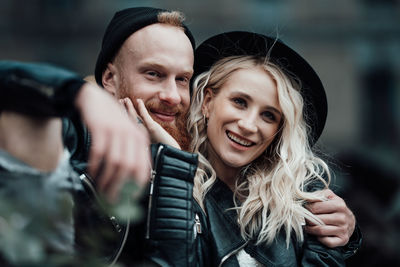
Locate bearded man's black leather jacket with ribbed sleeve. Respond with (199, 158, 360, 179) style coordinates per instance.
(0, 61, 202, 266)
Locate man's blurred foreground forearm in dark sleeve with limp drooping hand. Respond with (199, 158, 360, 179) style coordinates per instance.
(0, 61, 150, 199)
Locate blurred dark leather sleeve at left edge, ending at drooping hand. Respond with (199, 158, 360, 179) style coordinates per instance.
(0, 61, 84, 117)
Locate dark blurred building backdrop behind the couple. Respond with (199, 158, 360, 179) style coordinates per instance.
(0, 0, 400, 266)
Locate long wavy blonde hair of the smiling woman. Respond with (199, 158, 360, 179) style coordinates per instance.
(188, 56, 330, 246)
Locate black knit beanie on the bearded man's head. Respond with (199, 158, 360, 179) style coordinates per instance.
(94, 7, 195, 86)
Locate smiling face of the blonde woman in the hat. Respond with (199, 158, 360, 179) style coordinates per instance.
(203, 67, 282, 174)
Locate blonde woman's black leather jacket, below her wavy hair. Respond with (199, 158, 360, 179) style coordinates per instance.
(195, 180, 345, 266)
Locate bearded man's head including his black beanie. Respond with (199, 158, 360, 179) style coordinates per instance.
(95, 8, 195, 153)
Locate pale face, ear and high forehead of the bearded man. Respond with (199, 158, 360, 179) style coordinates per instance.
(102, 23, 193, 131)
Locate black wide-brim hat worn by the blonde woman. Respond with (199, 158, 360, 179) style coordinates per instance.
(193, 31, 328, 146)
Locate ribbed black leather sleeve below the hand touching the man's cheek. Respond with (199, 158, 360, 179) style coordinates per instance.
(146, 144, 198, 266)
